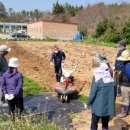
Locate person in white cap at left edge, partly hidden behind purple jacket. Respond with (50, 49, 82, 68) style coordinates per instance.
(0, 45, 11, 106)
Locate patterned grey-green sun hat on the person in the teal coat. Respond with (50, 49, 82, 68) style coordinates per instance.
(93, 54, 109, 63)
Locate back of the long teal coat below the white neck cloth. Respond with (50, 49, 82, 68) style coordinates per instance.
(92, 79, 116, 116)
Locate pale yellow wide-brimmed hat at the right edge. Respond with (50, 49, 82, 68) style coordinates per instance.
(117, 50, 130, 61)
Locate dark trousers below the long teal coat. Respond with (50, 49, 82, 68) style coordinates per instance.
(91, 113, 110, 130)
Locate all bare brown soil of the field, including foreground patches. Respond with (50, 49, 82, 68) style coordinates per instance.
(0, 42, 130, 130)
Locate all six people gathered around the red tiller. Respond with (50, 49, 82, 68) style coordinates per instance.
(0, 41, 130, 130)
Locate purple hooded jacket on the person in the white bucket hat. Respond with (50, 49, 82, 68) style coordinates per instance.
(2, 70, 23, 97)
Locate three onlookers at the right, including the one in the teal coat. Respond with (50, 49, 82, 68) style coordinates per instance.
(85, 41, 130, 130)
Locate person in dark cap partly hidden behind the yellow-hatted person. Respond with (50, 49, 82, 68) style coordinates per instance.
(114, 40, 126, 96)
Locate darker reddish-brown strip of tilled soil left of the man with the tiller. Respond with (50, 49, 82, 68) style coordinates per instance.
(1, 42, 55, 87)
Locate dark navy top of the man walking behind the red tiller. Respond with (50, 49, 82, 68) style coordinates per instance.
(50, 50, 66, 67)
